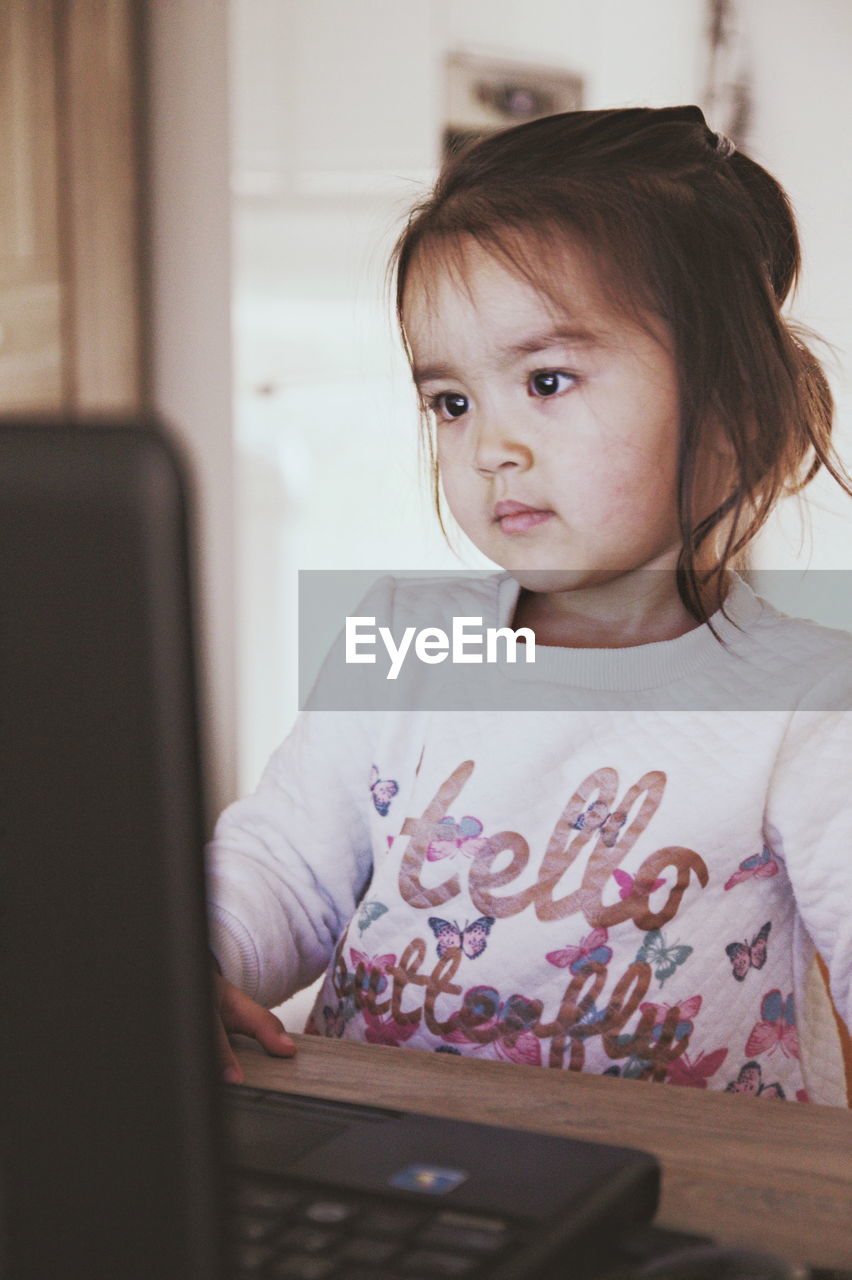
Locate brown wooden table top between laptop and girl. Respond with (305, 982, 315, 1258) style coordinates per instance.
(239, 1036, 852, 1267)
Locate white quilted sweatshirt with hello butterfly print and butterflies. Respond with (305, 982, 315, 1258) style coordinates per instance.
(210, 573, 852, 1106)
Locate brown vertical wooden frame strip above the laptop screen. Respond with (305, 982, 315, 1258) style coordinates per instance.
(54, 0, 148, 413)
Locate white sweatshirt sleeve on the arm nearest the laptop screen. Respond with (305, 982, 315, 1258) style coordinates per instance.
(207, 577, 393, 1006)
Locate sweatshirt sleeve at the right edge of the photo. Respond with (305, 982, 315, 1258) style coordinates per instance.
(766, 649, 852, 1027)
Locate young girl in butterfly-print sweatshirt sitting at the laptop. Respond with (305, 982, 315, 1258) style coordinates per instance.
(211, 108, 852, 1105)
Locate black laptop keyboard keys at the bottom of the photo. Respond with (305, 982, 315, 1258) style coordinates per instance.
(228, 1172, 516, 1280)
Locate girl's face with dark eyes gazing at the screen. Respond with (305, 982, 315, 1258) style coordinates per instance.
(404, 241, 681, 614)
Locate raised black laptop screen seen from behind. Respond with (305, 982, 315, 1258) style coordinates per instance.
(0, 421, 220, 1280)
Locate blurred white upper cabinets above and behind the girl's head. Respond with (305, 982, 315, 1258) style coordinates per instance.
(232, 0, 705, 182)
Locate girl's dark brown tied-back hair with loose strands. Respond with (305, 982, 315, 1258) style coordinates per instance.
(391, 106, 852, 622)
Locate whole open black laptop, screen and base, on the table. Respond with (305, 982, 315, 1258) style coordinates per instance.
(0, 421, 659, 1280)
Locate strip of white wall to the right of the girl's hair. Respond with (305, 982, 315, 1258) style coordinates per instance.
(743, 0, 852, 565)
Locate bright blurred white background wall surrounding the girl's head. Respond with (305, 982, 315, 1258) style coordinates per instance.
(230, 0, 852, 788)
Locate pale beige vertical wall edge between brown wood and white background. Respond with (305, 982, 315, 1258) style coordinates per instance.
(147, 0, 237, 812)
